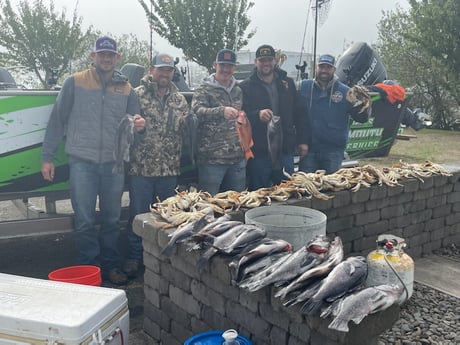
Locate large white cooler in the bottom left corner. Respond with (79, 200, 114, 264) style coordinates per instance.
(0, 273, 129, 345)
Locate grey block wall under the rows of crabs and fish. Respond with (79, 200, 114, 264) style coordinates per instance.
(134, 172, 460, 345)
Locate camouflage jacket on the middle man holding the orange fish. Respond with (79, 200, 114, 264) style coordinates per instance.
(192, 75, 244, 164)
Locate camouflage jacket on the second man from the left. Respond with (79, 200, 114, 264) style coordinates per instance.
(129, 75, 189, 176)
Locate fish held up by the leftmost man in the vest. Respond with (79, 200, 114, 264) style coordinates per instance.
(112, 114, 134, 174)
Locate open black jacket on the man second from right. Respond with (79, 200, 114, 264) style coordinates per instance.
(240, 68, 299, 158)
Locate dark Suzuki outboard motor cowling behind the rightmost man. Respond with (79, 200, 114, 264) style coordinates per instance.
(336, 42, 387, 86)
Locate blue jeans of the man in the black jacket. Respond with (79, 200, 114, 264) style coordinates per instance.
(247, 153, 294, 191)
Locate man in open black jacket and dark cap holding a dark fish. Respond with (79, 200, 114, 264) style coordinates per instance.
(240, 45, 307, 190)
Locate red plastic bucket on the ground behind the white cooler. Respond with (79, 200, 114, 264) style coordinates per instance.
(48, 265, 102, 286)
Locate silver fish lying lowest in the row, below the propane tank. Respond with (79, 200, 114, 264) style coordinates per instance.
(321, 284, 403, 332)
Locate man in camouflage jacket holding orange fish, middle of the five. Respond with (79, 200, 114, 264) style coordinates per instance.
(192, 49, 246, 194)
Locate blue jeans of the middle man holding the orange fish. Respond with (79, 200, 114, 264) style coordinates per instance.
(198, 159, 246, 195)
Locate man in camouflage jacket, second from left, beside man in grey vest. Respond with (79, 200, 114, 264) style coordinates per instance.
(123, 54, 189, 277)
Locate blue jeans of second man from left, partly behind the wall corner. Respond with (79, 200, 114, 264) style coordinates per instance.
(126, 175, 177, 261)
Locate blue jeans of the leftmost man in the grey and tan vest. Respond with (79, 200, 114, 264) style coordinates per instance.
(69, 160, 124, 273)
